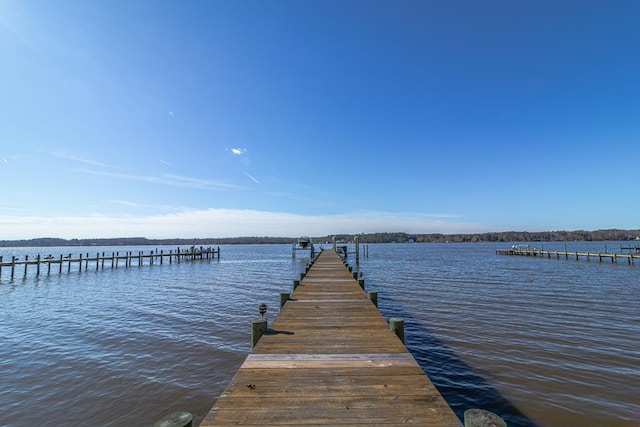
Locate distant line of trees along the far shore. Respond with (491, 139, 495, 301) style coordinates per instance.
(0, 229, 640, 247)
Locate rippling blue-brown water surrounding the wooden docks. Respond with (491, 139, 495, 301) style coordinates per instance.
(0, 242, 640, 427)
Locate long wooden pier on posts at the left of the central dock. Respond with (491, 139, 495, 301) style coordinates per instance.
(0, 247, 220, 280)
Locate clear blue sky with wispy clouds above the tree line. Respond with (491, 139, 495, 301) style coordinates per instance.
(0, 0, 640, 239)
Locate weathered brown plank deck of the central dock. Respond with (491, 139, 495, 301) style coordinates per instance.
(200, 250, 461, 427)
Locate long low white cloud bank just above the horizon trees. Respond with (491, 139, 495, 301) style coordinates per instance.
(0, 209, 486, 239)
